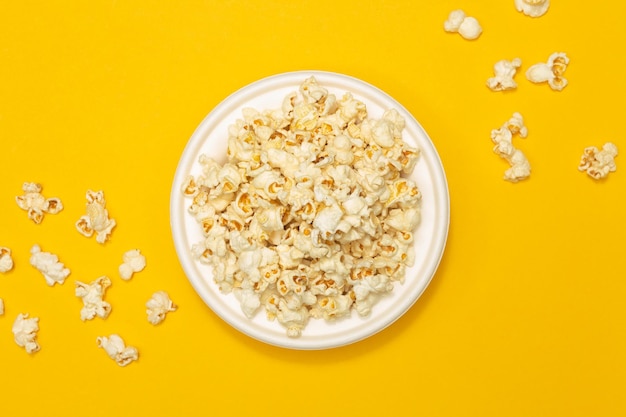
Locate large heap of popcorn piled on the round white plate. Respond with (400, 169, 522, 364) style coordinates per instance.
(183, 77, 422, 337)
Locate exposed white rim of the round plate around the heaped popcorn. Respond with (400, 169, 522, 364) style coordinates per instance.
(170, 71, 450, 350)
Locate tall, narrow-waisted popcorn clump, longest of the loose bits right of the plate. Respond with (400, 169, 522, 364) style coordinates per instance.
(491, 113, 530, 182)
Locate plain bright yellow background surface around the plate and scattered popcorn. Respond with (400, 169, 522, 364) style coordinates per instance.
(0, 0, 626, 417)
